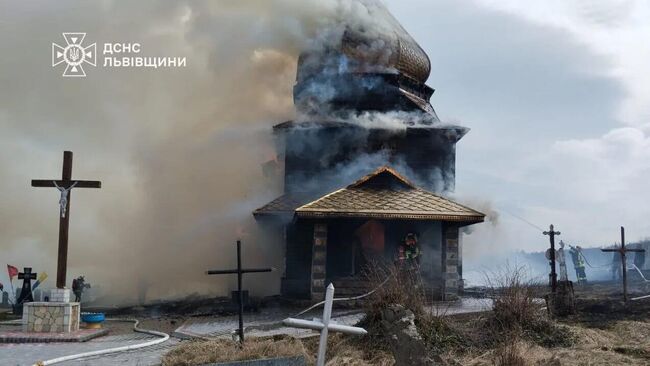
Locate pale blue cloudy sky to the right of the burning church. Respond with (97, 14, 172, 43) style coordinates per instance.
(387, 0, 650, 264)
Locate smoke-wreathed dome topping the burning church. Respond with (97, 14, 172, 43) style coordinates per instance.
(294, 0, 437, 119)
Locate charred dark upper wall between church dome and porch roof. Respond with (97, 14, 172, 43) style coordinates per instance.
(276, 123, 465, 193)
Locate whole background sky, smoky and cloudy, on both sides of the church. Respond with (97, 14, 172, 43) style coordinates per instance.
(0, 0, 650, 297)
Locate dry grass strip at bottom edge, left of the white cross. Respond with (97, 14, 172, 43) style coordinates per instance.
(162, 337, 310, 366)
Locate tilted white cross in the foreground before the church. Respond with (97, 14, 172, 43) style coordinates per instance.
(282, 283, 368, 366)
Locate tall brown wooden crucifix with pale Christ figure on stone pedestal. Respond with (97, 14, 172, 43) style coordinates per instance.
(32, 151, 102, 288)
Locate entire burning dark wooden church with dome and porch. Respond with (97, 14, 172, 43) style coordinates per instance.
(253, 2, 484, 299)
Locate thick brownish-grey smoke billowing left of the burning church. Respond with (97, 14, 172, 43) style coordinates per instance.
(0, 0, 404, 303)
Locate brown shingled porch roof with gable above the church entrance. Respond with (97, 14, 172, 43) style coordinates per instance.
(255, 167, 485, 224)
